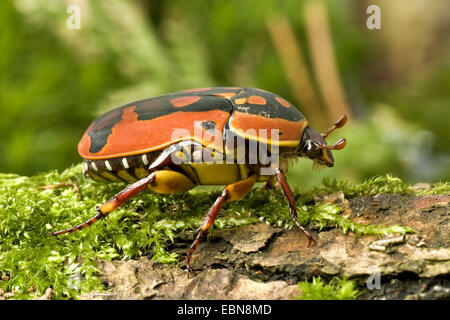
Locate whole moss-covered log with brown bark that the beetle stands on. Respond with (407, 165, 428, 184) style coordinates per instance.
(0, 165, 450, 299)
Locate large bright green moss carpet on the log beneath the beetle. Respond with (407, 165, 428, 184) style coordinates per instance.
(0, 165, 442, 299)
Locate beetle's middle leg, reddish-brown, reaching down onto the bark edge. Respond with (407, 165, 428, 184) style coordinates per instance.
(186, 175, 256, 272)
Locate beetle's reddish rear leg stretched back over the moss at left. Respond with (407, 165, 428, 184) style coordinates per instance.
(48, 173, 155, 236)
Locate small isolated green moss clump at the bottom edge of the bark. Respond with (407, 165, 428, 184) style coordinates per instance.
(297, 277, 362, 300)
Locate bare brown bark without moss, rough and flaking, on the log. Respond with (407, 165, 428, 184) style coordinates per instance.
(82, 192, 450, 299)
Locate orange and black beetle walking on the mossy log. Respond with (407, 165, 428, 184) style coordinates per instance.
(50, 87, 347, 271)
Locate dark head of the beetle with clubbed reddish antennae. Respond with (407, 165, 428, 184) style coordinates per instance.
(299, 115, 347, 167)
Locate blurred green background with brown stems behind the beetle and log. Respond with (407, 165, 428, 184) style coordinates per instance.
(0, 0, 450, 188)
